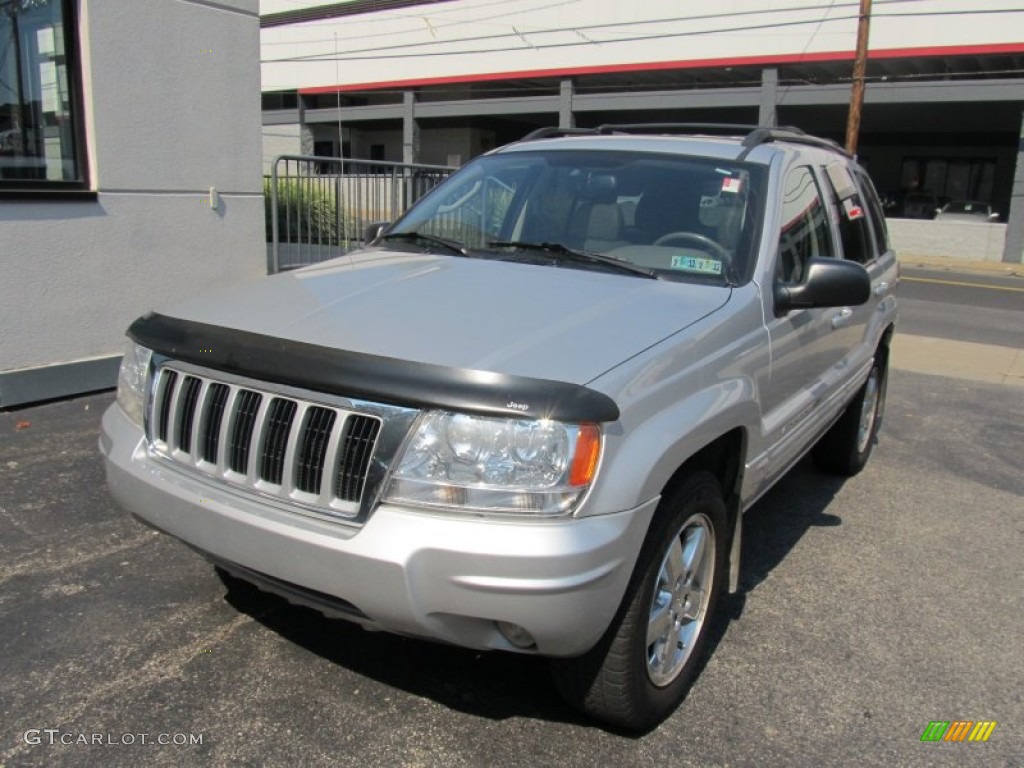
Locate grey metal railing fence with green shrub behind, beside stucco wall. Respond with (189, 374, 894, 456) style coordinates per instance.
(264, 155, 456, 273)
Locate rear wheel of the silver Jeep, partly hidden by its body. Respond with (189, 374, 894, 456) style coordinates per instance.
(812, 347, 889, 477)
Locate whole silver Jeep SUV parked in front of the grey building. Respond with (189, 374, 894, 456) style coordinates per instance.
(101, 125, 898, 729)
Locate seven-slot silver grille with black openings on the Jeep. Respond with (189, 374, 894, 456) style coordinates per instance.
(150, 367, 381, 517)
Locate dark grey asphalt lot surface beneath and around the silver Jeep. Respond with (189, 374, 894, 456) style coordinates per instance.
(0, 372, 1024, 767)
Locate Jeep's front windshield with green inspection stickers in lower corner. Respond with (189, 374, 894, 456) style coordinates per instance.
(386, 150, 766, 285)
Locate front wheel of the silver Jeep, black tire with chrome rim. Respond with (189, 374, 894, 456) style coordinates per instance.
(553, 472, 728, 730)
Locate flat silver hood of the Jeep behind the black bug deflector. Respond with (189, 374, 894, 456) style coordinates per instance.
(160, 250, 730, 384)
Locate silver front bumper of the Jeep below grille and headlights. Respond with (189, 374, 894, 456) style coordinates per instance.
(100, 404, 657, 656)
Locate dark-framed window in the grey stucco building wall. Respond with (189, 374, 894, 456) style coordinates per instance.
(0, 0, 86, 190)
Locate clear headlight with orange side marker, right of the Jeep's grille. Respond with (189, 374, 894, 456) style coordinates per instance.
(384, 412, 601, 515)
